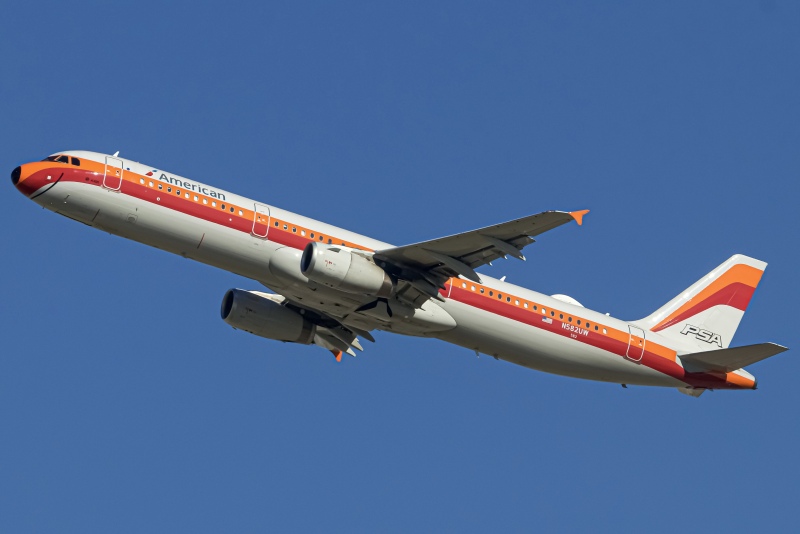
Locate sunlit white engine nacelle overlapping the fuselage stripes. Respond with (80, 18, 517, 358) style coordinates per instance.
(300, 243, 395, 297)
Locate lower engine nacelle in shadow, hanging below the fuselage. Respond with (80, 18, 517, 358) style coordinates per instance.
(220, 289, 317, 345)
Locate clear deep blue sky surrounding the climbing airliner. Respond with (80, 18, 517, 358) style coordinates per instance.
(0, 0, 800, 532)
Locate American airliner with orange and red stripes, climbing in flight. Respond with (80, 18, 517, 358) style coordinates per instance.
(11, 150, 787, 397)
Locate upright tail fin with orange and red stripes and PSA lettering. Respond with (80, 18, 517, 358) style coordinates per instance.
(635, 254, 767, 352)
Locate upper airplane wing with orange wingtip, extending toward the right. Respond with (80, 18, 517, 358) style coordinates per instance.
(374, 210, 589, 298)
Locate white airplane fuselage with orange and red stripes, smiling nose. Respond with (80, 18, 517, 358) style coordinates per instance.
(15, 151, 755, 389)
